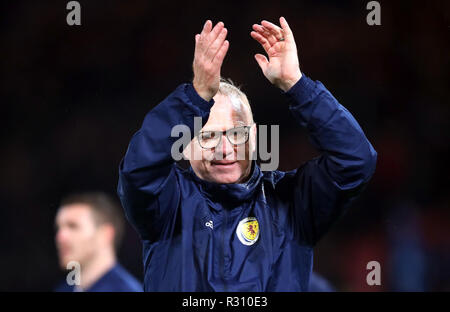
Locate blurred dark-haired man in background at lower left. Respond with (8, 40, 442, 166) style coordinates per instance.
(55, 192, 142, 292)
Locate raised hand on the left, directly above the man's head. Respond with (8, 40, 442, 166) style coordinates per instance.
(192, 20, 230, 101)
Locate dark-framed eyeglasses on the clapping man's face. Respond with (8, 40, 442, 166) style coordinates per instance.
(197, 126, 251, 149)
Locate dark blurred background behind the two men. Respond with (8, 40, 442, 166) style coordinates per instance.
(0, 0, 450, 291)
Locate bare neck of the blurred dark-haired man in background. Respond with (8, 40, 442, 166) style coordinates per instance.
(80, 248, 116, 290)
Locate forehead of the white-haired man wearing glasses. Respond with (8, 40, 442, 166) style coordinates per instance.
(202, 93, 248, 131)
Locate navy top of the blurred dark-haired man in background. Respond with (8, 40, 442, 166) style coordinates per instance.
(55, 263, 143, 292)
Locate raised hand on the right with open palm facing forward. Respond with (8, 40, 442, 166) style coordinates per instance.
(250, 17, 302, 92)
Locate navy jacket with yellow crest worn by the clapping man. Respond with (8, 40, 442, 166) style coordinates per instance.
(118, 75, 377, 291)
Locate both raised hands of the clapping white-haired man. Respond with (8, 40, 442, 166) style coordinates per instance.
(193, 17, 302, 101)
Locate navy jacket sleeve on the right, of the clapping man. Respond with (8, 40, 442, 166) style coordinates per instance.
(285, 75, 377, 245)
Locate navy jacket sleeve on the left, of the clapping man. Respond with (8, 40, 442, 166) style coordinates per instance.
(117, 84, 214, 240)
